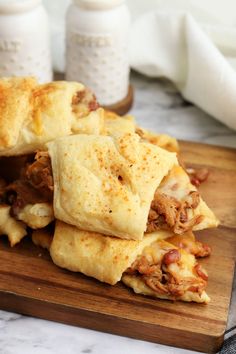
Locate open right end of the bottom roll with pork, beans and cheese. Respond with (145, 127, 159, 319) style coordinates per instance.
(122, 240, 210, 303)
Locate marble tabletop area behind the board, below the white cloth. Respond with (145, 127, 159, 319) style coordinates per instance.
(130, 73, 236, 147)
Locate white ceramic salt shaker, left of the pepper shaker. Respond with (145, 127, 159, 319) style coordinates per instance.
(0, 0, 52, 83)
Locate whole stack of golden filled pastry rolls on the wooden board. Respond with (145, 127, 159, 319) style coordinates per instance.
(0, 78, 218, 303)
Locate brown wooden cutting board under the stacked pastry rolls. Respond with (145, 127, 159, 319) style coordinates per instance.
(0, 142, 236, 352)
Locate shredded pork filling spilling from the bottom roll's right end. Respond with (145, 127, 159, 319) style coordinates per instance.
(126, 249, 208, 298)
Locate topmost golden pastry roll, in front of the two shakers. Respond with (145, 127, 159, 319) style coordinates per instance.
(0, 78, 103, 156)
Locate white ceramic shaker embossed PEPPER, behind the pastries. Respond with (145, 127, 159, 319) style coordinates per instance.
(66, 0, 130, 106)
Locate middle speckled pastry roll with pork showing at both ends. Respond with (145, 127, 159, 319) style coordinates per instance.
(3, 134, 218, 239)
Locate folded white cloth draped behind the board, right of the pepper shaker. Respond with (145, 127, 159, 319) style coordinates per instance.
(130, 11, 236, 133)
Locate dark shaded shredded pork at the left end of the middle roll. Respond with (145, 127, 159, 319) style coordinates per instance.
(0, 152, 53, 217)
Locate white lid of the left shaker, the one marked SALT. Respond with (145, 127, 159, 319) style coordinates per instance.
(0, 0, 42, 15)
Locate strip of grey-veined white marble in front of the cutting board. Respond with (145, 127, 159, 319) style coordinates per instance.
(0, 311, 196, 354)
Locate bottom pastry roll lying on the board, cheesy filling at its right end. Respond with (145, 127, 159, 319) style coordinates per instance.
(50, 221, 209, 303)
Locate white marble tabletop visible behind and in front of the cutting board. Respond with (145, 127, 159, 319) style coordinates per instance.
(0, 74, 236, 354)
